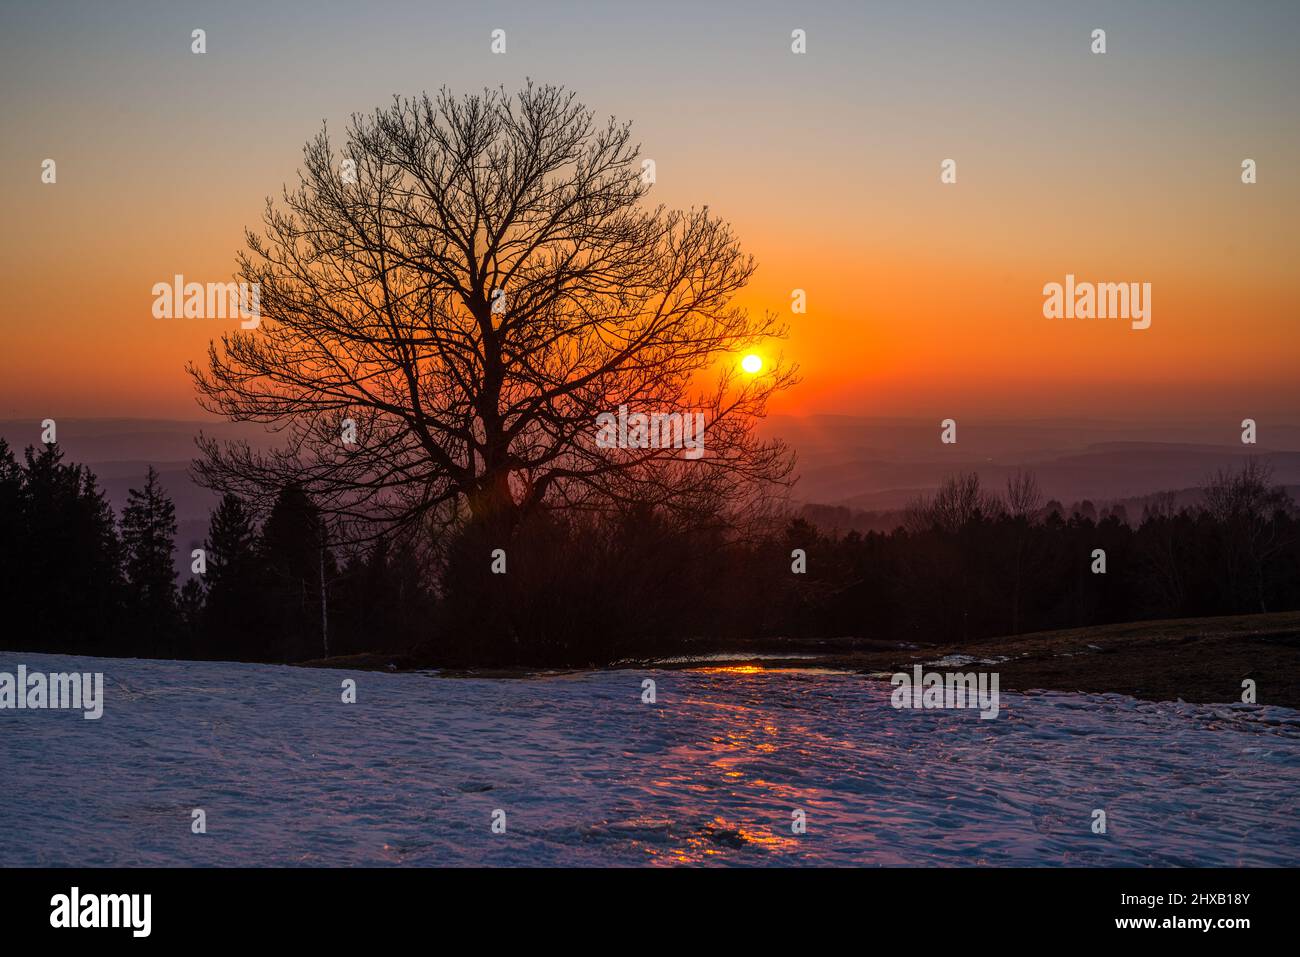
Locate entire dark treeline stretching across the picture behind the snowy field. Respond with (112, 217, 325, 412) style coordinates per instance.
(0, 441, 1300, 666)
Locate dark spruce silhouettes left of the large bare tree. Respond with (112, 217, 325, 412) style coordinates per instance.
(0, 439, 432, 662)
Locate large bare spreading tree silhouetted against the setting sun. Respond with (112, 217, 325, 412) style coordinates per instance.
(190, 83, 796, 532)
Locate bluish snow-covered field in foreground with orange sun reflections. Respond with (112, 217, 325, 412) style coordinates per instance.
(0, 653, 1300, 866)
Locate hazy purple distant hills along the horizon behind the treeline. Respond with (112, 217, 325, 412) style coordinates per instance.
(0, 415, 1300, 530)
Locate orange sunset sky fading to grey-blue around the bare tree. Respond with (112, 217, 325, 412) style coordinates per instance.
(0, 4, 1300, 421)
